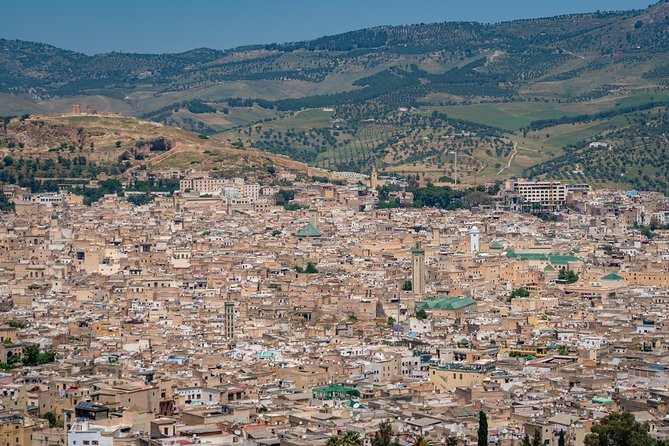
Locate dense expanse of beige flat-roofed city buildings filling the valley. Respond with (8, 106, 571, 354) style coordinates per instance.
(0, 176, 669, 446)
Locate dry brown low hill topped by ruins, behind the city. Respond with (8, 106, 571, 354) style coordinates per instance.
(0, 115, 315, 190)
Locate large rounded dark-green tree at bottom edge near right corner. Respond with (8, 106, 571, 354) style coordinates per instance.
(585, 412, 655, 446)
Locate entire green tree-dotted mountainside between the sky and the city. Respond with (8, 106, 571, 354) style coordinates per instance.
(0, 1, 669, 190)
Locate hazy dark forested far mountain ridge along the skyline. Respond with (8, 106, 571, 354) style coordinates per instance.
(0, 3, 669, 107)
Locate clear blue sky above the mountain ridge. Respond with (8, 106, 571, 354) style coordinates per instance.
(0, 0, 655, 54)
